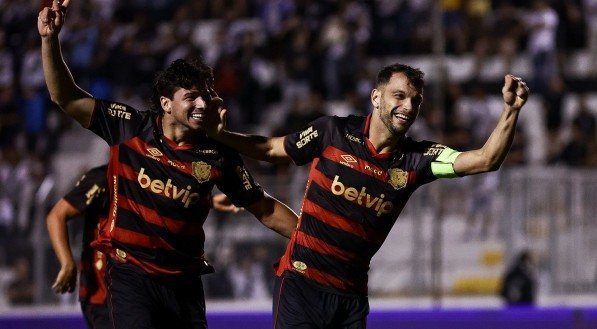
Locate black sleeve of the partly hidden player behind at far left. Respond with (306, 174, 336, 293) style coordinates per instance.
(64, 166, 107, 213)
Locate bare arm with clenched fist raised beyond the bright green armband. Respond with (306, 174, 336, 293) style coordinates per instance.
(454, 75, 529, 176)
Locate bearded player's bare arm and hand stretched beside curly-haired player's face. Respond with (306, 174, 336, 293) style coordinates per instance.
(205, 97, 290, 163)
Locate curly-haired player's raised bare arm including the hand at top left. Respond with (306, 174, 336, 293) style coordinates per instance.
(37, 0, 95, 127)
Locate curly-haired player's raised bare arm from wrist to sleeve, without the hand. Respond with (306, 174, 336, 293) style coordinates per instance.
(41, 36, 93, 125)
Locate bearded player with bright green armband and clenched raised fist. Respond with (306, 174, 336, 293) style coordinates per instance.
(205, 64, 528, 329)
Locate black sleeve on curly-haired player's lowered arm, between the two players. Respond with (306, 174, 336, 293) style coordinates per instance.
(216, 152, 264, 207)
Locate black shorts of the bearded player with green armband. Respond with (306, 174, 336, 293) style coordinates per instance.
(273, 272, 369, 329)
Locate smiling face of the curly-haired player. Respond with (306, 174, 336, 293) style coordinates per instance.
(162, 87, 207, 130)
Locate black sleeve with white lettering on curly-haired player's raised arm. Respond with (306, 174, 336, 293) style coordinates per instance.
(87, 99, 148, 145)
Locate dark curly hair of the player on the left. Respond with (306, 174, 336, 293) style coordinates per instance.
(151, 58, 214, 114)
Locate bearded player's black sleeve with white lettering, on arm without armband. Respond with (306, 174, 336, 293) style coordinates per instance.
(284, 116, 334, 166)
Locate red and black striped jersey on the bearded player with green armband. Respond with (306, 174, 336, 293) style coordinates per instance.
(277, 116, 458, 295)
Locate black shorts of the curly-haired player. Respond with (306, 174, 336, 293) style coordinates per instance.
(106, 260, 207, 329)
